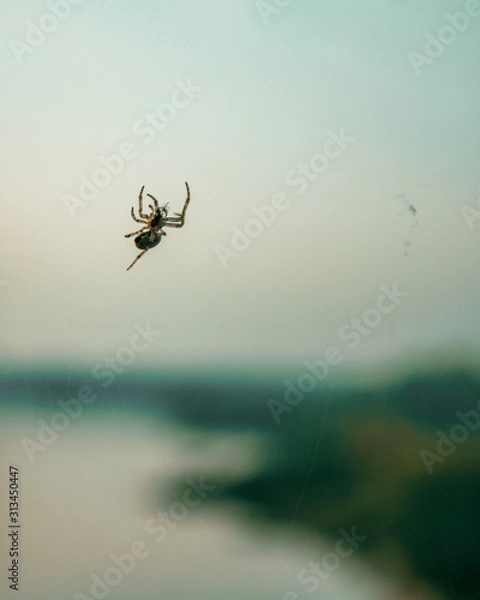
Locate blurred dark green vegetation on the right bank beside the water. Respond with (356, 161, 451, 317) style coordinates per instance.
(168, 370, 480, 600)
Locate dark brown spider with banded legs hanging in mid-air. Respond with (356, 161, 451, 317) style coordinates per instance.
(125, 182, 190, 271)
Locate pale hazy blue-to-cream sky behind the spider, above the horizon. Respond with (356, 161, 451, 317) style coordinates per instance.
(0, 0, 480, 368)
